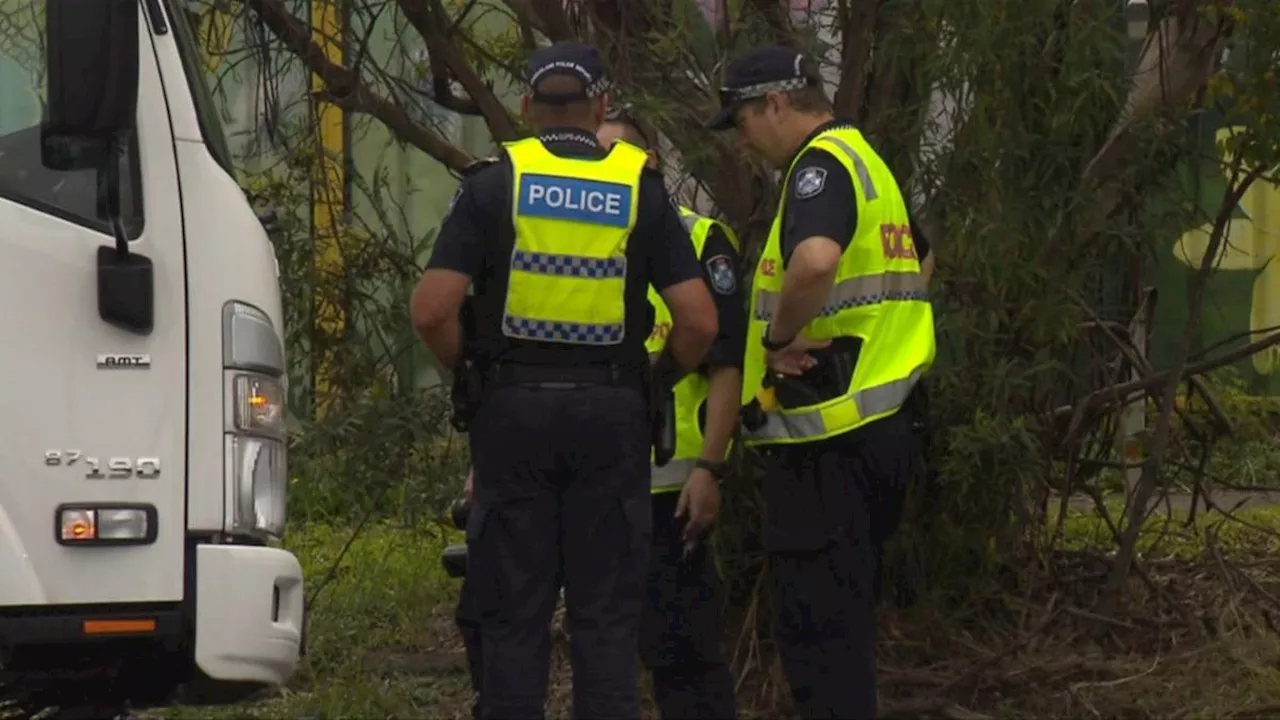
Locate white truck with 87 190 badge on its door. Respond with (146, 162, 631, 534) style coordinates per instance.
(0, 0, 303, 706)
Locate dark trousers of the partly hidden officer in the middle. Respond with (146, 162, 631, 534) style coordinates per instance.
(640, 492, 737, 720)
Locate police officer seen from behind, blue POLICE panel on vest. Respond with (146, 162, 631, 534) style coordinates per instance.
(411, 42, 717, 719)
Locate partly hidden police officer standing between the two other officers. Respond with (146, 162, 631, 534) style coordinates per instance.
(596, 105, 746, 720)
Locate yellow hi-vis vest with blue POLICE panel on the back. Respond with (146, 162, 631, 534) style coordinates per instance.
(502, 137, 645, 346)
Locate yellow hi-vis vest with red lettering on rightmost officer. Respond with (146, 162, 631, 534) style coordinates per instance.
(742, 127, 936, 446)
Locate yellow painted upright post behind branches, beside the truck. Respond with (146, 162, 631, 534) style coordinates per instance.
(311, 0, 347, 416)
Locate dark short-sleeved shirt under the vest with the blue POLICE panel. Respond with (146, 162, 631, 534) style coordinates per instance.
(426, 128, 703, 369)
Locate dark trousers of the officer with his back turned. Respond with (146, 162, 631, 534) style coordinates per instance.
(466, 384, 652, 720)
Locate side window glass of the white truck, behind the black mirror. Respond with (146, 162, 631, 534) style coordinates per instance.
(0, 0, 142, 238)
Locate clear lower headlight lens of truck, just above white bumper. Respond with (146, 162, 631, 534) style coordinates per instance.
(225, 434, 289, 538)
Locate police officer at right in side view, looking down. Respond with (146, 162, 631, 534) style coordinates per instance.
(708, 47, 934, 719)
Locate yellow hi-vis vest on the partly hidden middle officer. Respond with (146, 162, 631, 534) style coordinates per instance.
(644, 208, 739, 495)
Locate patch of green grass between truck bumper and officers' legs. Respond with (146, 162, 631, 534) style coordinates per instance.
(146, 524, 471, 720)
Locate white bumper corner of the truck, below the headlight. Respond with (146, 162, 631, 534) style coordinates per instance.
(196, 544, 303, 685)
